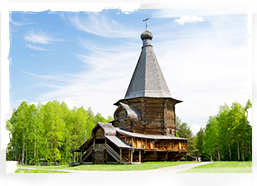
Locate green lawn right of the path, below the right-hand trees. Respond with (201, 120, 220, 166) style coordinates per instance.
(181, 161, 252, 173)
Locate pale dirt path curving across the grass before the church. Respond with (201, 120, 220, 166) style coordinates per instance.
(18, 162, 212, 174)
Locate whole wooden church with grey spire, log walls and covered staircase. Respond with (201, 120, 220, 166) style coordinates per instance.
(71, 25, 188, 164)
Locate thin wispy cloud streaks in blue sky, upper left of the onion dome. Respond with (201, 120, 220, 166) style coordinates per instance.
(69, 13, 137, 38)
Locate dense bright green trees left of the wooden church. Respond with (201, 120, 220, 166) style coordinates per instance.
(6, 101, 111, 165)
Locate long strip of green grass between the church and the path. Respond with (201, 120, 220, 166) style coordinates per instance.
(17, 161, 198, 171)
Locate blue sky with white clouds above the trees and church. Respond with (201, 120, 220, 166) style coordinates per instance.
(9, 9, 252, 133)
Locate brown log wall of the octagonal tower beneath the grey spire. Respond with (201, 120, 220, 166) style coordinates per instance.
(119, 98, 176, 136)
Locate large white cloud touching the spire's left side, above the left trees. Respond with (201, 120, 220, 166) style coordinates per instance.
(27, 42, 140, 117)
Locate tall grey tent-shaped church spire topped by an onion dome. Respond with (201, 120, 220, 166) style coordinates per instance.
(125, 30, 171, 99)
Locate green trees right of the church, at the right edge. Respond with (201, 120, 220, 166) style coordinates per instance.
(201, 100, 252, 161)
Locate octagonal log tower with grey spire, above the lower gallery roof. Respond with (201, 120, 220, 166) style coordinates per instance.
(113, 29, 182, 136)
